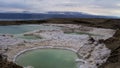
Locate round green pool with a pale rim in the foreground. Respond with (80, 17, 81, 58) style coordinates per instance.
(16, 49, 77, 68)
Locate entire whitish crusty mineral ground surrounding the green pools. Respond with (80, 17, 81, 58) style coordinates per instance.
(0, 24, 115, 68)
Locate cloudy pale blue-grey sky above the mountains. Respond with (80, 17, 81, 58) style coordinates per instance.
(0, 0, 120, 17)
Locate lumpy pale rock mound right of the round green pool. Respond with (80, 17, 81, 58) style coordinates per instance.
(77, 40, 111, 68)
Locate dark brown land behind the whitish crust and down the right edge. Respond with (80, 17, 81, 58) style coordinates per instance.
(0, 19, 120, 68)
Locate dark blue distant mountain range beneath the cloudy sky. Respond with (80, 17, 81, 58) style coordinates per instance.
(0, 12, 117, 20)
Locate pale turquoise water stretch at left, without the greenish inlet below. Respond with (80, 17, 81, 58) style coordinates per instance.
(0, 24, 59, 34)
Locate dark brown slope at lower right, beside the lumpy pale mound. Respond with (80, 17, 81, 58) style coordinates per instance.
(100, 30, 120, 68)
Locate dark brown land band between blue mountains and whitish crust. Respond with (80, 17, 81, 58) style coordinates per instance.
(0, 18, 120, 29)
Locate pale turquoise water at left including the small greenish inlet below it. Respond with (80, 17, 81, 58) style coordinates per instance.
(0, 24, 60, 39)
